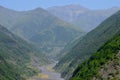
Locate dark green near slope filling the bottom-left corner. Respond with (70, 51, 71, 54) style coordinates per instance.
(0, 55, 24, 80)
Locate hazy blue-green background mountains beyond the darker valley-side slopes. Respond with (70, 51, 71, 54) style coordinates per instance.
(0, 5, 119, 56)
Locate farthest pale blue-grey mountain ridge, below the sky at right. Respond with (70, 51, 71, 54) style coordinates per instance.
(47, 4, 120, 32)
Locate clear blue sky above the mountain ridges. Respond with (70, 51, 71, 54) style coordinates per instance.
(0, 0, 120, 11)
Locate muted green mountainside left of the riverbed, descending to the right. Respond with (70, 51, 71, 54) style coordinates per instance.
(0, 25, 50, 80)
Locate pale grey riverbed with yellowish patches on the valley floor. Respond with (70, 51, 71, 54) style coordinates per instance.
(29, 63, 64, 80)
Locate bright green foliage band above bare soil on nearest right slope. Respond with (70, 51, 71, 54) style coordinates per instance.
(71, 36, 120, 80)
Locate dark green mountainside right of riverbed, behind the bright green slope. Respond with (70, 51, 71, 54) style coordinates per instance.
(55, 11, 120, 78)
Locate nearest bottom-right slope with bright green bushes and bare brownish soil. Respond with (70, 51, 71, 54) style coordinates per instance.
(70, 35, 120, 80)
